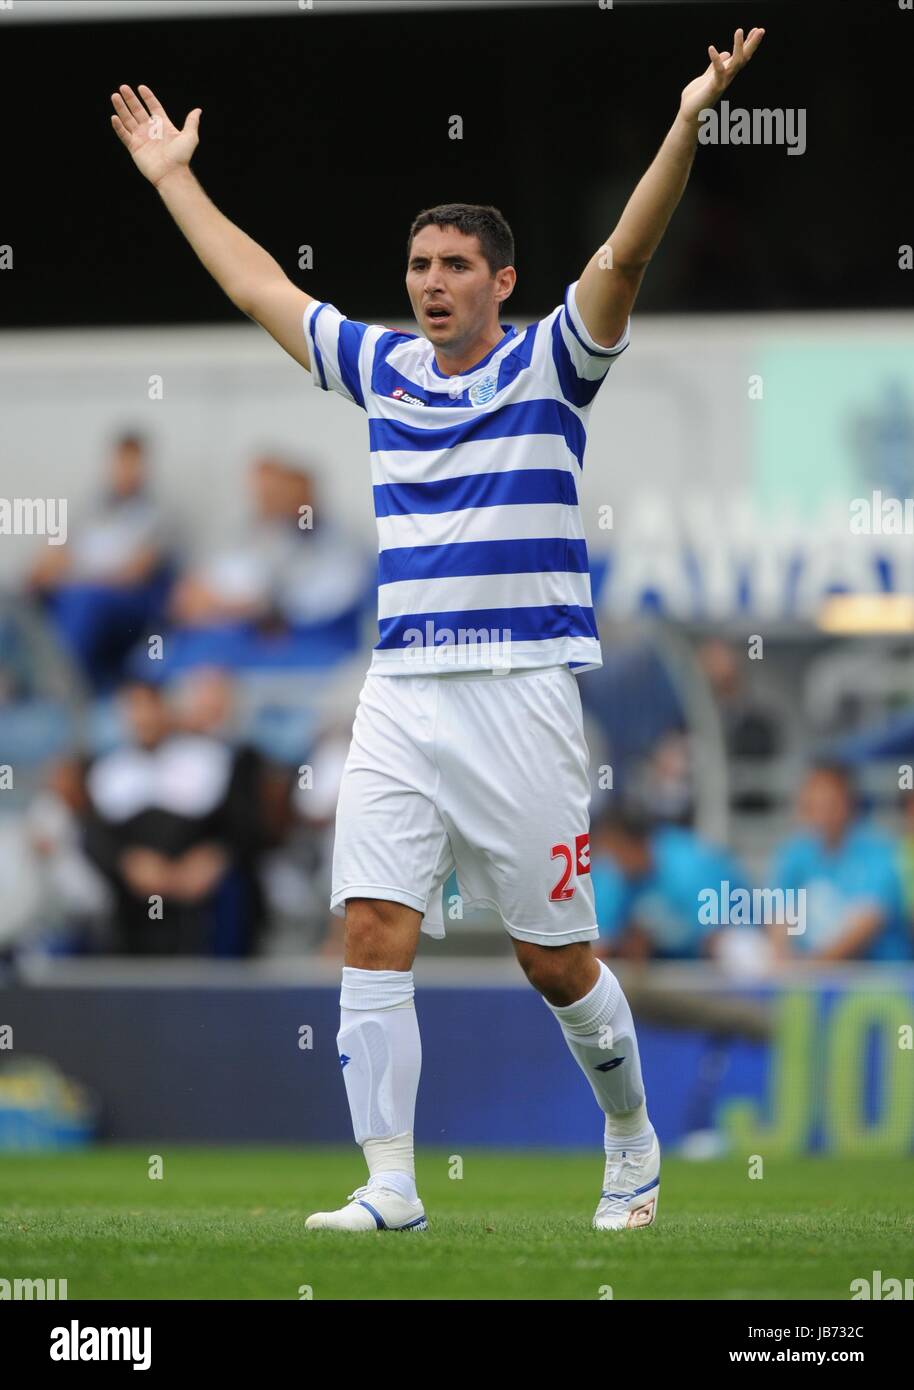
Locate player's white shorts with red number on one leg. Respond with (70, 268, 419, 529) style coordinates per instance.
(331, 666, 599, 947)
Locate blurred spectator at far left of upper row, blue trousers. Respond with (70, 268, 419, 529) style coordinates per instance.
(31, 434, 171, 691)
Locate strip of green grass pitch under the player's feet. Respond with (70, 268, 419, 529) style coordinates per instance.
(0, 1145, 914, 1300)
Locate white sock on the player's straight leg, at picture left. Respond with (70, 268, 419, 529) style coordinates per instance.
(336, 966, 422, 1201)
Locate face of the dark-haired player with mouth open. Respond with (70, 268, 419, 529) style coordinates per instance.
(406, 227, 504, 349)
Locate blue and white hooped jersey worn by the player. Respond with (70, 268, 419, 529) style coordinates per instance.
(304, 281, 629, 676)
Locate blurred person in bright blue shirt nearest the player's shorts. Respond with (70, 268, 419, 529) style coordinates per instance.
(590, 810, 753, 960)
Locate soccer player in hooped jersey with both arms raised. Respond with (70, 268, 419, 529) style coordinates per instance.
(111, 29, 764, 1232)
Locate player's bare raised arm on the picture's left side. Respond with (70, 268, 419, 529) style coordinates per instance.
(111, 86, 313, 370)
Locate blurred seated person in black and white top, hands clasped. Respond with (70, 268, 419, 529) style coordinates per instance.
(80, 682, 258, 955)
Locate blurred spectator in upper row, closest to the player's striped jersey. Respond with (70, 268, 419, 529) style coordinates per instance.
(164, 456, 374, 666)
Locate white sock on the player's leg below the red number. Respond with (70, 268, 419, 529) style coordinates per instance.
(546, 960, 654, 1154)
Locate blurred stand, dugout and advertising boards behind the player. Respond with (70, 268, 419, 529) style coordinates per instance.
(0, 0, 914, 1158)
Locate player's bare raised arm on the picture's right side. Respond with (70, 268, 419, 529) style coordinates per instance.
(575, 29, 765, 348)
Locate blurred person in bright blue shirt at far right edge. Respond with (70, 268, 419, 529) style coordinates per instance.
(771, 765, 911, 960)
